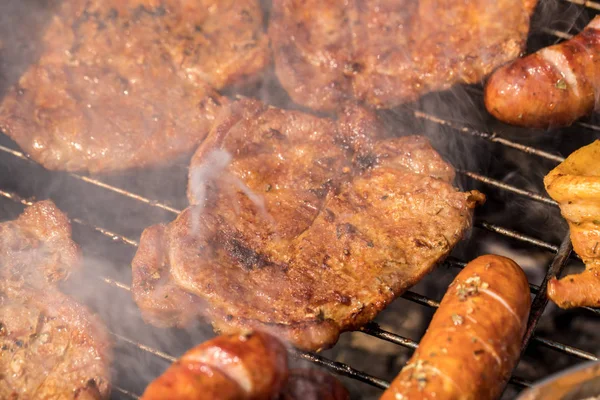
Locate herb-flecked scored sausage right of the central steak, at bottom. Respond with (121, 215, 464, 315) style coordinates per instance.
(381, 255, 531, 400)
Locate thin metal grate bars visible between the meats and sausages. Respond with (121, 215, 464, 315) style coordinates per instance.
(0, 0, 600, 398)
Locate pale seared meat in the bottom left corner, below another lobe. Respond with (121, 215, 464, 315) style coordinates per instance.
(0, 281, 110, 400)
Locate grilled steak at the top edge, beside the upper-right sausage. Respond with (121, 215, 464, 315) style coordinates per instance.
(269, 0, 537, 110)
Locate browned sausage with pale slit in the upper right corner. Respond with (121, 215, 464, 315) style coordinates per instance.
(485, 17, 600, 128)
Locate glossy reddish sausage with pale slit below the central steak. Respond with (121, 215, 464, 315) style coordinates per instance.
(142, 332, 288, 400)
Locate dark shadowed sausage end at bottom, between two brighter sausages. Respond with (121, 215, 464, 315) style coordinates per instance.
(279, 369, 350, 400)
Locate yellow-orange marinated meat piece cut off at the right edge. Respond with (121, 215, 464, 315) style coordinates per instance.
(544, 141, 600, 308)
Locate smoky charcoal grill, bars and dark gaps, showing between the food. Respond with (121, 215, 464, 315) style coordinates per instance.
(0, 0, 600, 399)
